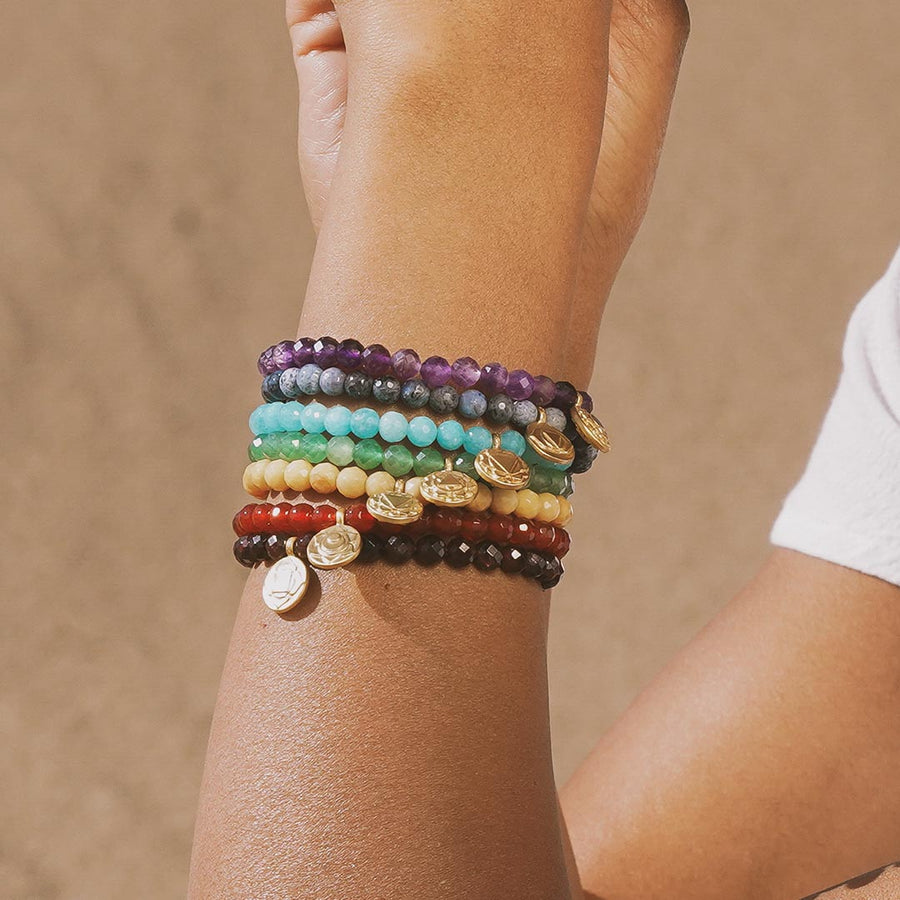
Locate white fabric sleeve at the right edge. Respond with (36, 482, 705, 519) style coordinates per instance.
(770, 251, 900, 585)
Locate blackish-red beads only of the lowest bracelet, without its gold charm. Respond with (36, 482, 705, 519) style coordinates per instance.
(234, 534, 563, 590)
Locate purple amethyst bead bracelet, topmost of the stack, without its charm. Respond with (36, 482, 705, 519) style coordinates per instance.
(258, 337, 594, 412)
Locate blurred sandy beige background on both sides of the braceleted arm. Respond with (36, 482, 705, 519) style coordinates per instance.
(0, 0, 900, 900)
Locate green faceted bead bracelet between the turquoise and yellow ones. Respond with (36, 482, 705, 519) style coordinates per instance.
(245, 431, 572, 497)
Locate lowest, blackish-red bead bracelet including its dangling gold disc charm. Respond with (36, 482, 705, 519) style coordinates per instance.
(234, 534, 563, 600)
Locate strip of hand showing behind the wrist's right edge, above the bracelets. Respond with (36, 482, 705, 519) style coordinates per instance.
(567, 0, 690, 383)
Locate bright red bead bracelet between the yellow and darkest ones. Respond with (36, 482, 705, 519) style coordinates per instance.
(231, 502, 571, 558)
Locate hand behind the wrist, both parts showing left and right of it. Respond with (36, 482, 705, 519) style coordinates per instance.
(286, 0, 689, 383)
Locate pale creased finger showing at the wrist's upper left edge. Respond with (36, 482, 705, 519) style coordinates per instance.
(285, 0, 347, 230)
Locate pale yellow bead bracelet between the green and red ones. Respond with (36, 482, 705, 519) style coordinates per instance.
(243, 459, 573, 528)
